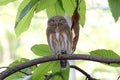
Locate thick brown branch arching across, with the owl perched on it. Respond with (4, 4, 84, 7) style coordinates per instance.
(0, 54, 120, 80)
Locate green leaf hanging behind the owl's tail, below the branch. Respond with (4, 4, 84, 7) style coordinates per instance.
(52, 61, 70, 80)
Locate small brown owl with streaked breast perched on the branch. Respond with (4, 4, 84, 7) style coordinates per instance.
(46, 16, 72, 69)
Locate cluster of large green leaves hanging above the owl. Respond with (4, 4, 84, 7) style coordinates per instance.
(15, 0, 86, 36)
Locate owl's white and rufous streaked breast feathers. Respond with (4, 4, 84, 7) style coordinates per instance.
(48, 31, 72, 54)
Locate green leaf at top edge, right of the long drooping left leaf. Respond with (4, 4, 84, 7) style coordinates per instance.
(36, 0, 57, 12)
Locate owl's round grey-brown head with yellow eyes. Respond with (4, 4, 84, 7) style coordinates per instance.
(48, 16, 67, 26)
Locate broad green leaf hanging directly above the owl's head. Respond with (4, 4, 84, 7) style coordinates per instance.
(46, 0, 64, 18)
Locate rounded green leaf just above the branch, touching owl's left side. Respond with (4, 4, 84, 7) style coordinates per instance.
(31, 44, 51, 56)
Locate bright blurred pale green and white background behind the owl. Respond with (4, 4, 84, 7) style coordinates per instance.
(0, 0, 120, 80)
